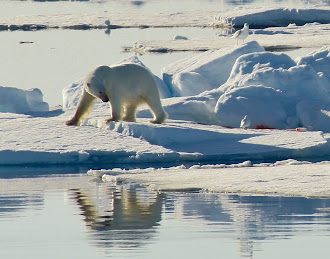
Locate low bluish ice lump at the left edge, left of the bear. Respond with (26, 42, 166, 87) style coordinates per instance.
(0, 86, 49, 114)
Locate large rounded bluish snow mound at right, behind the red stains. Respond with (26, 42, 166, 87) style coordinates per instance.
(215, 49, 330, 131)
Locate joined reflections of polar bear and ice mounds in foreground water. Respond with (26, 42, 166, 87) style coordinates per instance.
(69, 184, 330, 258)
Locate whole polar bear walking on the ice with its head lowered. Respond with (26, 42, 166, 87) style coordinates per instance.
(66, 63, 167, 126)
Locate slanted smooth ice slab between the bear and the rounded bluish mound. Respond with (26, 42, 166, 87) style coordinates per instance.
(162, 41, 264, 96)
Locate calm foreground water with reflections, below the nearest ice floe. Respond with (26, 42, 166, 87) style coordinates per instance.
(0, 174, 330, 258)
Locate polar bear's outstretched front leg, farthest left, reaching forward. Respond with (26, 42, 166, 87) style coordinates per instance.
(65, 88, 95, 126)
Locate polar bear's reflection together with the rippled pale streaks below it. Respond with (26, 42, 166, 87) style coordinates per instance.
(69, 184, 165, 253)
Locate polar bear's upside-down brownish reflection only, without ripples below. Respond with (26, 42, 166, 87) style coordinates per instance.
(70, 185, 164, 231)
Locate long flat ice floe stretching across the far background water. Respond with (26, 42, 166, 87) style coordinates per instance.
(0, 7, 330, 30)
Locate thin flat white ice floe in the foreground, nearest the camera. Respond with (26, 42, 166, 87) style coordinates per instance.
(98, 160, 330, 197)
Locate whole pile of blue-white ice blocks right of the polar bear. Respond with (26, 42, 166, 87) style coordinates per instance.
(157, 42, 330, 132)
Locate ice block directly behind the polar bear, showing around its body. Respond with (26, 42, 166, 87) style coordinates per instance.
(62, 56, 170, 110)
